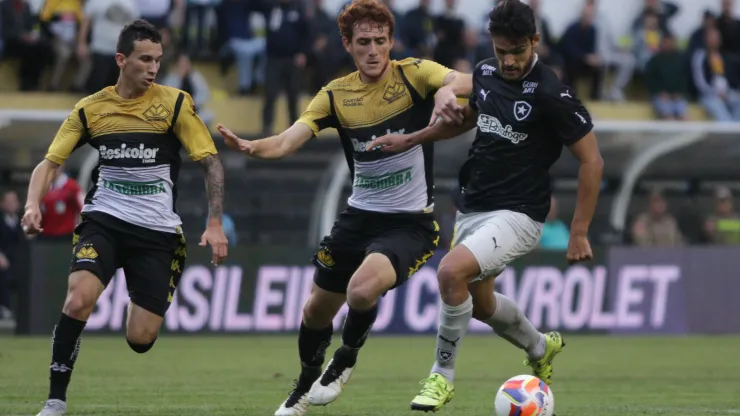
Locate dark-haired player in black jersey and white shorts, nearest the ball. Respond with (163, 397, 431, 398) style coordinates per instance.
(369, 0, 603, 411)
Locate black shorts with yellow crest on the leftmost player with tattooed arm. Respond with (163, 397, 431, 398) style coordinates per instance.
(70, 212, 187, 316)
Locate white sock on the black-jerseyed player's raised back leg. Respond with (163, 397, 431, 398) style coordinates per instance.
(485, 293, 545, 360)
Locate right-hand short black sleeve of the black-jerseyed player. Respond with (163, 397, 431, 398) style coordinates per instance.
(543, 85, 594, 146)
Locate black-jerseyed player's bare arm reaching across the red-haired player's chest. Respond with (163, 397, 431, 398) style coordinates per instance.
(367, 107, 478, 153)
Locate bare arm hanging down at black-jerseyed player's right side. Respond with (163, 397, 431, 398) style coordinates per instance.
(568, 131, 604, 263)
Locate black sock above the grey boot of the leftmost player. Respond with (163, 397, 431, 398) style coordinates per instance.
(49, 314, 86, 401)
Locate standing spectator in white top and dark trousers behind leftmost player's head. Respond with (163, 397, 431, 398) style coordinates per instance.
(77, 0, 139, 93)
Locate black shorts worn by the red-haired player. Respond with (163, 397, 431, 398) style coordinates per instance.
(313, 207, 439, 293)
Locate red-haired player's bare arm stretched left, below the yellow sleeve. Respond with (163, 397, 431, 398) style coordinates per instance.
(218, 123, 313, 159)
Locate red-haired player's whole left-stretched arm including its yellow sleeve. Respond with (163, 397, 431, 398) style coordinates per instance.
(218, 89, 337, 159)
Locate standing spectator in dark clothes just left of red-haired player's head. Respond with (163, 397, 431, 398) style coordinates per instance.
(262, 0, 311, 136)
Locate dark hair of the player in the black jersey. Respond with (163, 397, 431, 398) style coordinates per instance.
(488, 0, 537, 40)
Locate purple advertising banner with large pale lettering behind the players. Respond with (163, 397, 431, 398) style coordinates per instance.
(23, 246, 740, 334)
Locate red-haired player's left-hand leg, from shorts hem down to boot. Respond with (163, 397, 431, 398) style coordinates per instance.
(275, 280, 349, 416)
